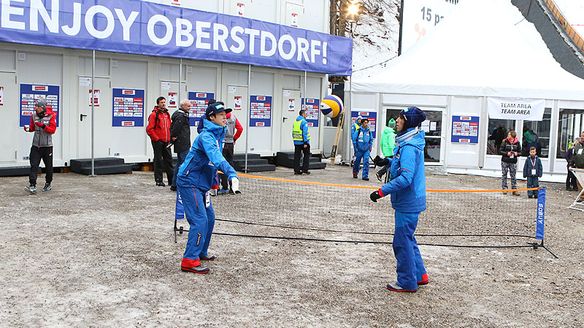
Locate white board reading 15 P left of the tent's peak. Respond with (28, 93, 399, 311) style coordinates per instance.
(401, 0, 460, 53)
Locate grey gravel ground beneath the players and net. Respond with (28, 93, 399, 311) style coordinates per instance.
(0, 166, 584, 327)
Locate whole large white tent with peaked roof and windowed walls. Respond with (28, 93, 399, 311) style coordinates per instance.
(349, 0, 584, 181)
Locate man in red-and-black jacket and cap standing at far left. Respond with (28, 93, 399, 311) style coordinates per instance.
(24, 99, 57, 194)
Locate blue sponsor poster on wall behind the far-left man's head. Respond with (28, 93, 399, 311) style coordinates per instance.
(20, 84, 59, 127)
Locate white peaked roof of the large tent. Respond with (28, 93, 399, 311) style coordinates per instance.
(352, 0, 584, 100)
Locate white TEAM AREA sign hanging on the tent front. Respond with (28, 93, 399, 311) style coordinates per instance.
(487, 97, 545, 121)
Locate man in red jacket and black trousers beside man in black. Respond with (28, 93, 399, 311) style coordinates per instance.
(146, 97, 173, 187)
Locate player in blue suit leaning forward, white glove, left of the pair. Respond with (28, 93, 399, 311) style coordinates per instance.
(176, 103, 240, 274)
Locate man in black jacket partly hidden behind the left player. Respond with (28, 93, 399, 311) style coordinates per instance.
(170, 99, 191, 191)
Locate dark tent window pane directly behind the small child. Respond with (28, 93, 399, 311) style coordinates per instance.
(521, 108, 552, 158)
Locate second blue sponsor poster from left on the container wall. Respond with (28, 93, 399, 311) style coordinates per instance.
(112, 88, 144, 127)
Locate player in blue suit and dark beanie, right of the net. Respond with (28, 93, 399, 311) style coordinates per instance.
(370, 107, 428, 293)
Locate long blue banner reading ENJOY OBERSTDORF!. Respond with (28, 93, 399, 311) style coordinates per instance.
(0, 0, 352, 75)
